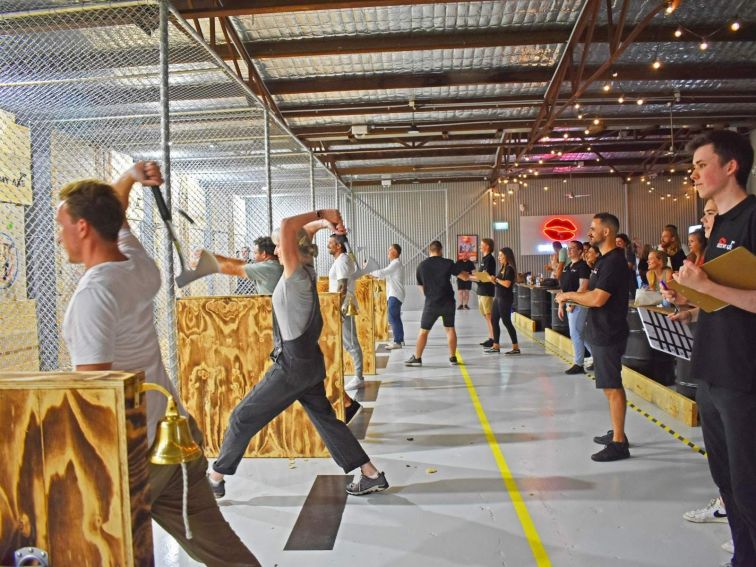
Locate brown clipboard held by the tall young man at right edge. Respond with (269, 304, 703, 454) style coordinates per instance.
(666, 246, 756, 313)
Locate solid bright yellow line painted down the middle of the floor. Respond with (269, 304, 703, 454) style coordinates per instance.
(457, 352, 551, 567)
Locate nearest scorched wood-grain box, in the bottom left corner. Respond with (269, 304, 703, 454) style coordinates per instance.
(0, 372, 153, 567)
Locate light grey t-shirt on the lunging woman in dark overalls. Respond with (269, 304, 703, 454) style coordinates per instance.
(273, 266, 316, 341)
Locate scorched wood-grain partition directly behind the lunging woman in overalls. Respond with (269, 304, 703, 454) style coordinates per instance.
(177, 294, 344, 457)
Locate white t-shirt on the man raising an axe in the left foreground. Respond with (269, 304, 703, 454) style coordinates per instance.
(63, 229, 186, 444)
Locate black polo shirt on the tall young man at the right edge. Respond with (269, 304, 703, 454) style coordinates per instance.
(691, 195, 756, 392)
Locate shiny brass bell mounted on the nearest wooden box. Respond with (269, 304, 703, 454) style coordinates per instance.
(142, 383, 202, 465)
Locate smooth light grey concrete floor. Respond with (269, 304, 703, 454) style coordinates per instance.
(155, 310, 730, 567)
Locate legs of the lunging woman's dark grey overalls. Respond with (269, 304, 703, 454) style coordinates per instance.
(213, 364, 370, 474)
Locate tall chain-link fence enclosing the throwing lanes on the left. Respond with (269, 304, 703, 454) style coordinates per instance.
(0, 0, 343, 378)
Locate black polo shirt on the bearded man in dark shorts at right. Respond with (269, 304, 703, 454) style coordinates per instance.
(586, 248, 630, 346)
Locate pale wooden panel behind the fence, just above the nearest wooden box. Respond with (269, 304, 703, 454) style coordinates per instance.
(0, 299, 39, 371)
